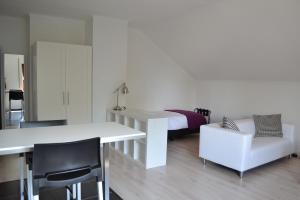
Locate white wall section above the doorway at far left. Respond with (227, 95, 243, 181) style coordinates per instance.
(0, 16, 28, 55)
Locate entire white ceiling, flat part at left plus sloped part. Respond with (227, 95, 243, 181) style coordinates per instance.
(0, 0, 300, 81)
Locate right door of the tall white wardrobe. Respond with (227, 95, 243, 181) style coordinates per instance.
(66, 45, 92, 124)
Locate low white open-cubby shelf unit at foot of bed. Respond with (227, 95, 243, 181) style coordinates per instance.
(106, 110, 168, 169)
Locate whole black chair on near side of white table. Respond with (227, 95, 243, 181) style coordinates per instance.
(32, 138, 103, 200)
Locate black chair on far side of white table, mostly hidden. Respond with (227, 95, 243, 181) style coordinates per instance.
(20, 119, 67, 200)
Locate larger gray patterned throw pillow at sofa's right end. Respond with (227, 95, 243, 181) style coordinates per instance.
(253, 114, 283, 137)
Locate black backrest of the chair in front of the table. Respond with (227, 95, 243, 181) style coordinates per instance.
(32, 138, 101, 181)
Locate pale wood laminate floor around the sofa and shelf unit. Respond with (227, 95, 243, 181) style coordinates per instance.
(110, 135, 300, 200)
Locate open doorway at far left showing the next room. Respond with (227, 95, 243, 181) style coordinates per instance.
(3, 54, 25, 128)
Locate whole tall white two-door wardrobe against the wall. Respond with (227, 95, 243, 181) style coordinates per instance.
(33, 42, 92, 124)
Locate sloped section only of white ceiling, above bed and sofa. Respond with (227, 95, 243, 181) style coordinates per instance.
(140, 0, 300, 81)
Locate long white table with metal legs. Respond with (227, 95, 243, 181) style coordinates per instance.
(0, 122, 146, 200)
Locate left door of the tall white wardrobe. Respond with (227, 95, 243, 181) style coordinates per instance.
(35, 42, 66, 120)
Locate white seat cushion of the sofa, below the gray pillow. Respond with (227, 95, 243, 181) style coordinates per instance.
(248, 137, 292, 168)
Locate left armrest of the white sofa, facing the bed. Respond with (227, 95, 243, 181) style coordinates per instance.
(199, 125, 253, 171)
